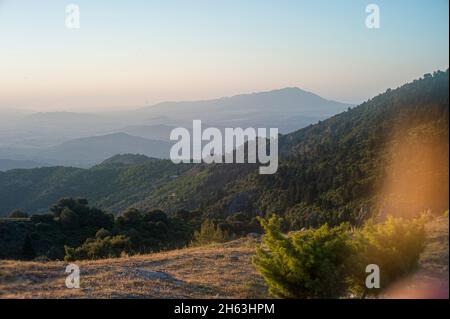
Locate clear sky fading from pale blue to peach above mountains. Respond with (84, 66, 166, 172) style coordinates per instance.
(0, 0, 449, 111)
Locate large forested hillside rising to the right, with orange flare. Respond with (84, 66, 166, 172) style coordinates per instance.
(135, 71, 449, 228)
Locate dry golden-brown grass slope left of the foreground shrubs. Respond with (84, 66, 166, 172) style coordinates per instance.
(0, 239, 267, 298)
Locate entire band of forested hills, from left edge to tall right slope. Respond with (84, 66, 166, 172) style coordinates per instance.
(0, 70, 449, 228)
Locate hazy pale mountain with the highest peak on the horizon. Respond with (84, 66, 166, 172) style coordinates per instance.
(131, 88, 351, 133)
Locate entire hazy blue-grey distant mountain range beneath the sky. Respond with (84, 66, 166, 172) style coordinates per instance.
(0, 88, 350, 170)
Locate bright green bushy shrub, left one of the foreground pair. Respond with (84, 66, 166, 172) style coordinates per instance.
(254, 216, 353, 298)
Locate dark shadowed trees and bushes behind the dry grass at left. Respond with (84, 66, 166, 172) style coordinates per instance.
(0, 198, 197, 260)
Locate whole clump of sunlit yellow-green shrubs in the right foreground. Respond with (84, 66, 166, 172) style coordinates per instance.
(254, 216, 425, 298)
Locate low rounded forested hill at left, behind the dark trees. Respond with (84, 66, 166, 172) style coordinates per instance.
(0, 154, 188, 216)
